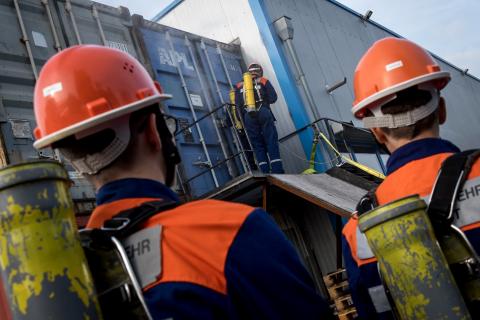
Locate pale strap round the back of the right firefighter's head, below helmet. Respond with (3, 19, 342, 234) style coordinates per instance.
(363, 85, 440, 129)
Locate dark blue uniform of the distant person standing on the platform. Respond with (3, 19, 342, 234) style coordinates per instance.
(235, 77, 284, 173)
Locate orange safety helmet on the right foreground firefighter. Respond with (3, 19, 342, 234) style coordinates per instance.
(352, 37, 450, 122)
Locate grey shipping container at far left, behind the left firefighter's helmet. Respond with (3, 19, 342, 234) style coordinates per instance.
(0, 0, 146, 212)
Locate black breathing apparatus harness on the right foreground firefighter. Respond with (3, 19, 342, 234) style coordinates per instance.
(356, 149, 480, 316)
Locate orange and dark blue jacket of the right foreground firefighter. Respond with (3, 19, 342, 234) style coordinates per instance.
(343, 138, 480, 319)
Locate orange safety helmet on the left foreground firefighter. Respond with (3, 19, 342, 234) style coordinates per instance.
(33, 45, 171, 149)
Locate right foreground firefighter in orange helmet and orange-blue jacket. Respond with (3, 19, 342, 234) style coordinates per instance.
(343, 38, 480, 319)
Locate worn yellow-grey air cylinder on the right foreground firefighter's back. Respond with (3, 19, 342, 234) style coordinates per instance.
(359, 195, 470, 319)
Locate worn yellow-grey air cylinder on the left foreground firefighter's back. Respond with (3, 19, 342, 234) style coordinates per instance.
(0, 161, 102, 320)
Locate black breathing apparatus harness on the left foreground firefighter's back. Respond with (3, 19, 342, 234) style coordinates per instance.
(80, 201, 178, 320)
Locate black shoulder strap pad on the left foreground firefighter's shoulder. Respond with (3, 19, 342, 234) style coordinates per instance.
(102, 200, 178, 238)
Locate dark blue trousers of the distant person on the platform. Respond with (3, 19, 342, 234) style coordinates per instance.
(245, 106, 284, 173)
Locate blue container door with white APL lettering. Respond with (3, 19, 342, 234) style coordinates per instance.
(136, 28, 235, 197)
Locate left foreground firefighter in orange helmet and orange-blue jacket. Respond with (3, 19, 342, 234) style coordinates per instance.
(34, 45, 327, 319)
